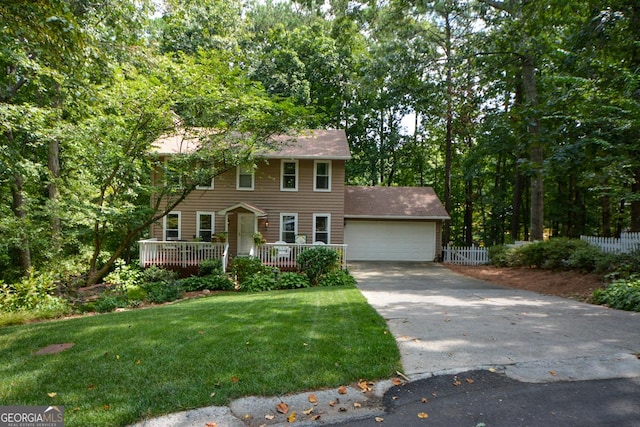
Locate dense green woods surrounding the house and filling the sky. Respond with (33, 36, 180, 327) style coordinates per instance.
(0, 0, 640, 280)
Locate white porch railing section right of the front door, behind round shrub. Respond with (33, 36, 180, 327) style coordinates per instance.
(250, 243, 347, 270)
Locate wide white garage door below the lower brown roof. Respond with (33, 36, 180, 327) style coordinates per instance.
(344, 219, 436, 261)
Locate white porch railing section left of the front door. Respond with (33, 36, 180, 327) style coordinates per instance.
(138, 239, 229, 271)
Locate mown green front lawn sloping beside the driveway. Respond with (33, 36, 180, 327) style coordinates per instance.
(0, 287, 400, 426)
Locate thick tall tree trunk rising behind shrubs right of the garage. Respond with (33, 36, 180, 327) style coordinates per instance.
(522, 55, 544, 240)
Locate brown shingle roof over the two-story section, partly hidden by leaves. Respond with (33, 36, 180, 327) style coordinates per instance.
(153, 128, 351, 160)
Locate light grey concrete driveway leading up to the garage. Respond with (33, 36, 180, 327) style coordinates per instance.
(350, 262, 640, 382)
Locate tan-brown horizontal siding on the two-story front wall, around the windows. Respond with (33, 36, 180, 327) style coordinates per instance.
(151, 159, 345, 244)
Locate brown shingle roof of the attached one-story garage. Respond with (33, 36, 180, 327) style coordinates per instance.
(344, 186, 450, 220)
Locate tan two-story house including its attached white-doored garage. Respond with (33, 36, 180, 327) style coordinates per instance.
(142, 130, 449, 272)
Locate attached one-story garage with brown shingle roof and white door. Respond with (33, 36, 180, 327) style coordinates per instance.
(344, 187, 449, 261)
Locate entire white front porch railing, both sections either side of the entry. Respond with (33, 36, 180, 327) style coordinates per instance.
(138, 239, 347, 274)
